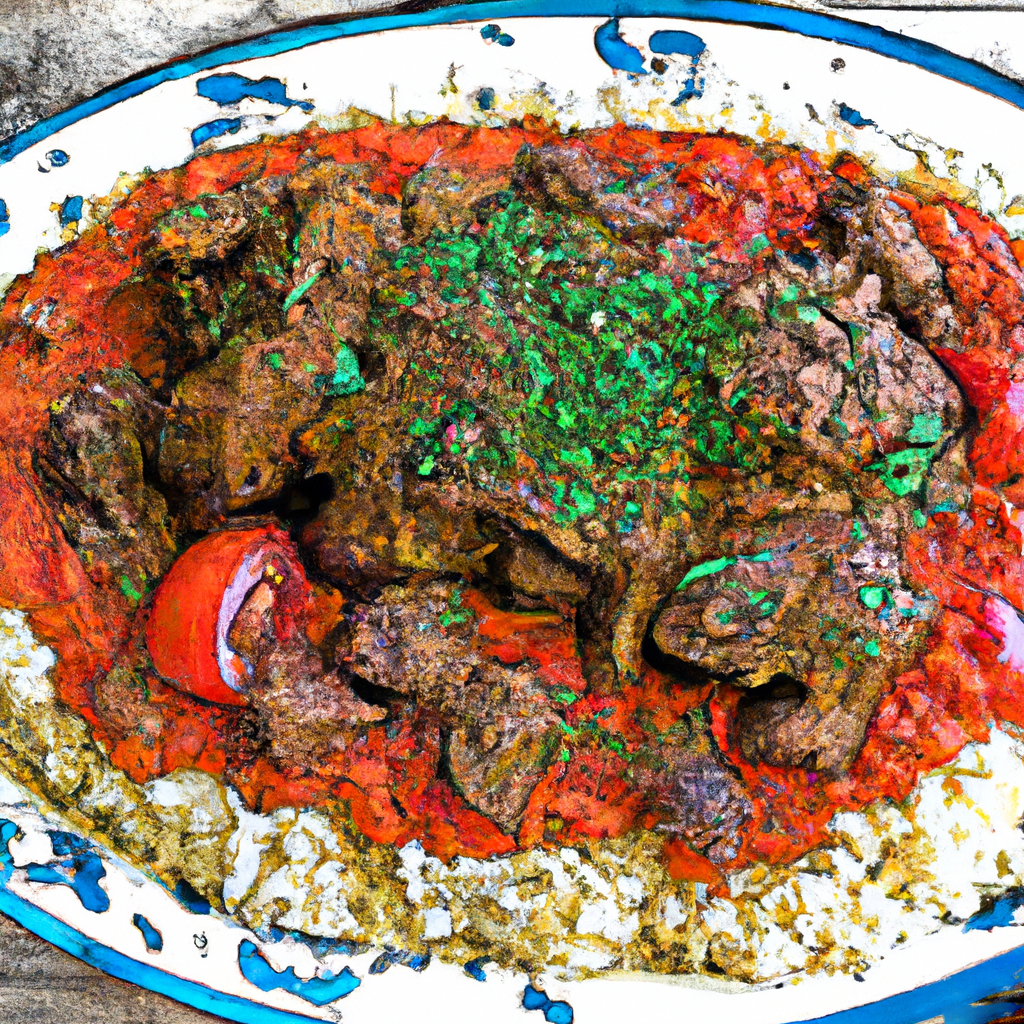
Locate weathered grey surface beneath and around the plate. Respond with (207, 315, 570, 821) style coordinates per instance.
(0, 0, 1024, 1024)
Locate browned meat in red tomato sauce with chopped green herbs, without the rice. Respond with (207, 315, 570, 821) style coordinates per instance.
(0, 121, 1024, 929)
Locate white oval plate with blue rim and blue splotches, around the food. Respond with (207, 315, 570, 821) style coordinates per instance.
(0, 8, 1024, 1024)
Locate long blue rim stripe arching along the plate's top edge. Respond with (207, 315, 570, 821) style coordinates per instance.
(0, 0, 1024, 164)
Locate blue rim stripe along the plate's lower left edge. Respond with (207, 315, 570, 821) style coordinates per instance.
(0, 881, 323, 1024)
